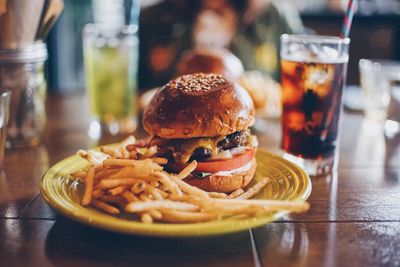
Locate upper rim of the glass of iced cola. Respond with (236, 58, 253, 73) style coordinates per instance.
(281, 33, 350, 44)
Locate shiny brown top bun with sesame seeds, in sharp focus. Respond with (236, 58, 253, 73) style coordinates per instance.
(143, 73, 255, 139)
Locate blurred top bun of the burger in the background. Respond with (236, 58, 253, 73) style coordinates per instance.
(177, 48, 244, 79)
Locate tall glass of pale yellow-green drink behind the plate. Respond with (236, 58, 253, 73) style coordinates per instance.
(83, 24, 138, 138)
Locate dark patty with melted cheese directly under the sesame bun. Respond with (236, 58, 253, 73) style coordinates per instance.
(150, 129, 258, 164)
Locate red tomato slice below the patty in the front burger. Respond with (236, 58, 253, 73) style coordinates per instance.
(167, 149, 256, 173)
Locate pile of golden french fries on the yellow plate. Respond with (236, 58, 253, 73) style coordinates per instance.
(71, 136, 309, 223)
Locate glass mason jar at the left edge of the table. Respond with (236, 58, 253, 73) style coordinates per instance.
(0, 42, 47, 147)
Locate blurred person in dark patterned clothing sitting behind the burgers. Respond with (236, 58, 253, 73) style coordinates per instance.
(139, 0, 303, 89)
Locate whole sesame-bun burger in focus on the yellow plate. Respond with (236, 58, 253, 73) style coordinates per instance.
(143, 73, 258, 193)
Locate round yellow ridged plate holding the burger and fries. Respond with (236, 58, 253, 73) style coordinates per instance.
(40, 149, 311, 237)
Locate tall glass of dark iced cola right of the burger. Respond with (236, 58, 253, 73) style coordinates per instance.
(281, 34, 350, 176)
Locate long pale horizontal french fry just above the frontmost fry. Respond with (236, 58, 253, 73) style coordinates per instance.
(125, 200, 198, 213)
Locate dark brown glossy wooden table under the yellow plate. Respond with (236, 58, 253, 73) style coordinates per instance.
(0, 96, 400, 267)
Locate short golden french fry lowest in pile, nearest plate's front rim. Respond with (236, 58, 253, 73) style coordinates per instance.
(159, 209, 219, 223)
